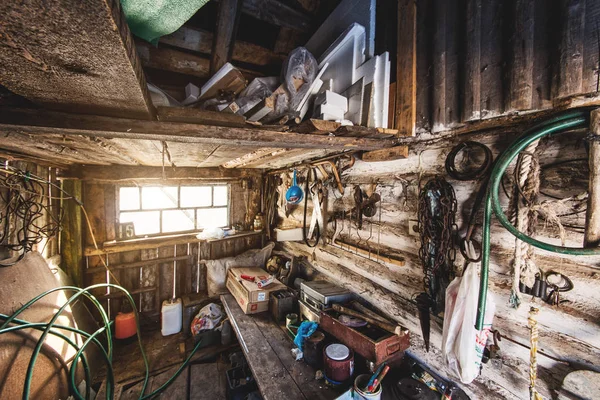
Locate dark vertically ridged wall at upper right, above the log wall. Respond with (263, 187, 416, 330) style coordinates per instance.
(410, 0, 600, 133)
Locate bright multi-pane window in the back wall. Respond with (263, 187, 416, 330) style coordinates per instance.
(118, 185, 229, 236)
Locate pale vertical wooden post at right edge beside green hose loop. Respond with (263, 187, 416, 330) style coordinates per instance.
(584, 108, 600, 247)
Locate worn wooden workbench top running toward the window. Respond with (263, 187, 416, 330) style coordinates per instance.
(221, 294, 339, 400)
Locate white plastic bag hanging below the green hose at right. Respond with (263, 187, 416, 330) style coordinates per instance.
(442, 264, 496, 383)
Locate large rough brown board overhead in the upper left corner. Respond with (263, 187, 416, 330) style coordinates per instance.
(0, 0, 153, 119)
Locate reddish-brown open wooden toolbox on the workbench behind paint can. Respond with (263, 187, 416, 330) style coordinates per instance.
(319, 309, 410, 365)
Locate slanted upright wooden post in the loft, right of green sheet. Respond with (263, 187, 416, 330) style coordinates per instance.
(210, 0, 243, 75)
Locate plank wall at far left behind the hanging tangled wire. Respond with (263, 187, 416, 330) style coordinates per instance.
(0, 158, 60, 266)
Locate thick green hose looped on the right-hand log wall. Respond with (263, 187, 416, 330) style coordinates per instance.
(475, 111, 600, 330)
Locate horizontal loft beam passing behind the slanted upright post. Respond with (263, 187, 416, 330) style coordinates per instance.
(160, 26, 283, 66)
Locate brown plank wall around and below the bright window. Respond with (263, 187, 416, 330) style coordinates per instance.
(83, 179, 262, 315)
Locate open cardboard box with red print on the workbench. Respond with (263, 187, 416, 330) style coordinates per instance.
(226, 268, 286, 314)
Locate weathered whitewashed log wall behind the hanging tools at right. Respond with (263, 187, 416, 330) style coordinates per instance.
(279, 127, 600, 399)
